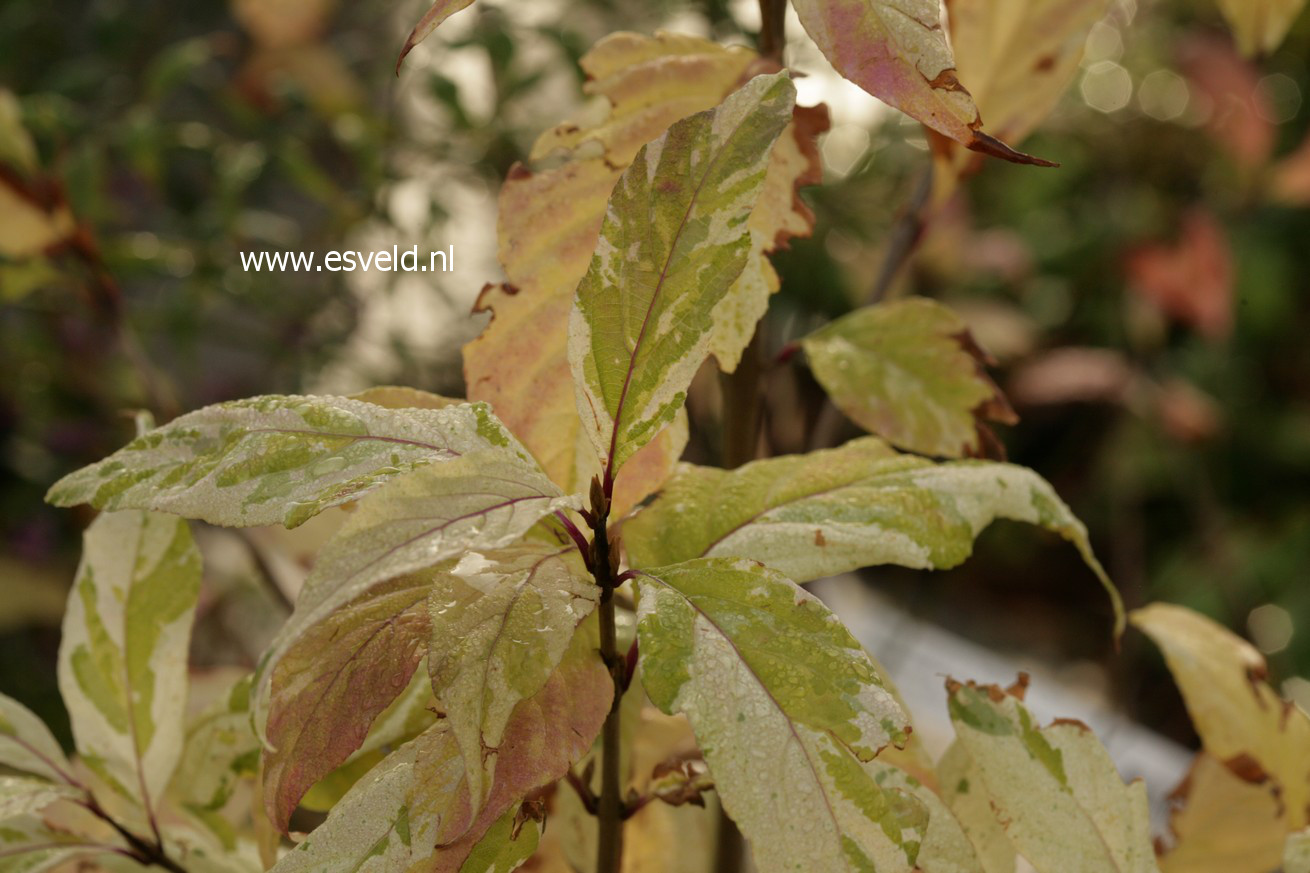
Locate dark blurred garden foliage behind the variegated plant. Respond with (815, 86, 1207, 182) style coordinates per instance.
(0, 0, 1310, 739)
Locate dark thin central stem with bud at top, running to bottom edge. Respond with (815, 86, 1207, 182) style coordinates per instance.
(591, 482, 627, 873)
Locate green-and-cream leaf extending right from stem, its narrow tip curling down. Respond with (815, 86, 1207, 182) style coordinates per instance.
(624, 437, 1123, 623)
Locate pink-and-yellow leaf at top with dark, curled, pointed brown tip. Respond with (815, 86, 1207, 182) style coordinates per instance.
(794, 0, 1055, 166)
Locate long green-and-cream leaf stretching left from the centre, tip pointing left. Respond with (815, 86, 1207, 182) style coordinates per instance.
(46, 396, 525, 527)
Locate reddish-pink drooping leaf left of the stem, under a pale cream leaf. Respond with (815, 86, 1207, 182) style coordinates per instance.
(263, 573, 431, 831)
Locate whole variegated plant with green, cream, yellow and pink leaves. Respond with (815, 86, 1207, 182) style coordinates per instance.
(0, 0, 1310, 873)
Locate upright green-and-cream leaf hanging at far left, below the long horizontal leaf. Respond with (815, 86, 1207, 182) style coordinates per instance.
(59, 511, 200, 811)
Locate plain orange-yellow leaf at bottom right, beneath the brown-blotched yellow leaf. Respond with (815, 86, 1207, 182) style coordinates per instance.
(1159, 752, 1288, 873)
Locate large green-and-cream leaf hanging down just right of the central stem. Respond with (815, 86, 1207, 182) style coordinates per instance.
(637, 558, 926, 873)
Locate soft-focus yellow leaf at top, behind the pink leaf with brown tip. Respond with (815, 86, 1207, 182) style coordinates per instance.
(937, 0, 1110, 187)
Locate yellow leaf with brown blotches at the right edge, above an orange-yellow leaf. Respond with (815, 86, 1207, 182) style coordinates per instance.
(1129, 603, 1310, 831)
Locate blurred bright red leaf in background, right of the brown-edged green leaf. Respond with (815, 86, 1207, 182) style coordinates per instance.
(1128, 210, 1233, 340)
